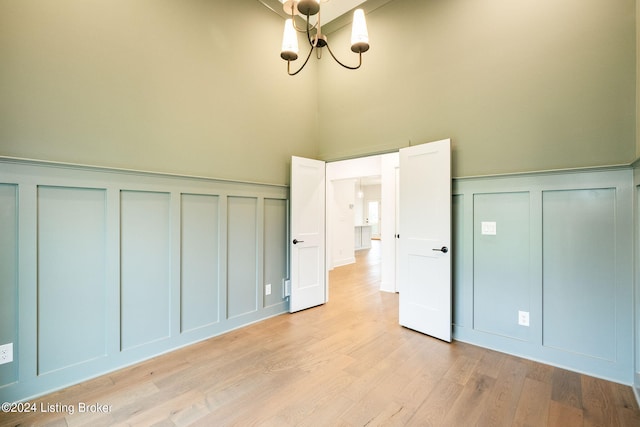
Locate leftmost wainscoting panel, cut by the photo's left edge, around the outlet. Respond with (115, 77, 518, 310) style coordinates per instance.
(0, 184, 18, 387)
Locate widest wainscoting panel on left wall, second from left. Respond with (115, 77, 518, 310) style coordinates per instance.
(37, 186, 107, 375)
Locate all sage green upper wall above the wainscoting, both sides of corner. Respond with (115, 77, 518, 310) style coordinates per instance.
(0, 0, 640, 184)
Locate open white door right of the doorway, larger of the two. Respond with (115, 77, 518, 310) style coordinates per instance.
(399, 139, 451, 342)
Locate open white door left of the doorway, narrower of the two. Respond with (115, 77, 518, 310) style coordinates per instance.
(289, 157, 327, 313)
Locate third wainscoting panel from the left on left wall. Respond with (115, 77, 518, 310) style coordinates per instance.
(120, 191, 171, 350)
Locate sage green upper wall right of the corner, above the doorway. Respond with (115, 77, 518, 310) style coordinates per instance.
(318, 0, 636, 176)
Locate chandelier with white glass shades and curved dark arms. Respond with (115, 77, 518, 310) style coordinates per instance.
(280, 0, 369, 76)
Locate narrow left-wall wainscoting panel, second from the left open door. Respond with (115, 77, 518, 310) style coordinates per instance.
(227, 197, 258, 319)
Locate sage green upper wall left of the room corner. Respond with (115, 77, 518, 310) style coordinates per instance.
(0, 0, 317, 184)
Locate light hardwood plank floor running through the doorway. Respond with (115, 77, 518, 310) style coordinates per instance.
(5, 242, 640, 427)
